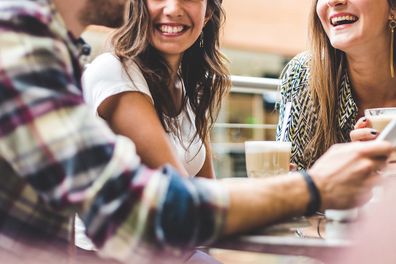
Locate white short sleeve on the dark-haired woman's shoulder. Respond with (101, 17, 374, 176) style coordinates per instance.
(82, 53, 154, 113)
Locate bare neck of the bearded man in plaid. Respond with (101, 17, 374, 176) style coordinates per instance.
(52, 0, 86, 38)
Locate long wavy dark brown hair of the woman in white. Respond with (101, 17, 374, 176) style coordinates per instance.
(112, 0, 231, 145)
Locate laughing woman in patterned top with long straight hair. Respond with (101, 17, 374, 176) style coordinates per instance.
(277, 0, 396, 169)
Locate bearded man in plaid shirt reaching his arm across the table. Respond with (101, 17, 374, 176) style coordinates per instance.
(0, 0, 391, 263)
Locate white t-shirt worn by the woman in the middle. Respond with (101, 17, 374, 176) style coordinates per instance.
(83, 53, 206, 176)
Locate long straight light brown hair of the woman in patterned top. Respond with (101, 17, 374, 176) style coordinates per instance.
(304, 0, 396, 166)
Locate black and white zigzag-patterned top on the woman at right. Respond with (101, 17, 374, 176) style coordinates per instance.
(276, 52, 358, 169)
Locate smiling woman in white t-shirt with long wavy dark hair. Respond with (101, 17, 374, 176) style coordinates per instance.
(84, 0, 230, 178)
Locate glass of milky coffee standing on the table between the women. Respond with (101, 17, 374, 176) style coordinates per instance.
(245, 141, 291, 178)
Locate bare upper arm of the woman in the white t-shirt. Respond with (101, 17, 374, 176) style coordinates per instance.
(98, 92, 188, 176)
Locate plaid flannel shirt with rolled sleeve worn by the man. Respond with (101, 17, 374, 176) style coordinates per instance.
(0, 0, 228, 260)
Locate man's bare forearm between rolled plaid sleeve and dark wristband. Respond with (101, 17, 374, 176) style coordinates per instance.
(222, 172, 309, 235)
